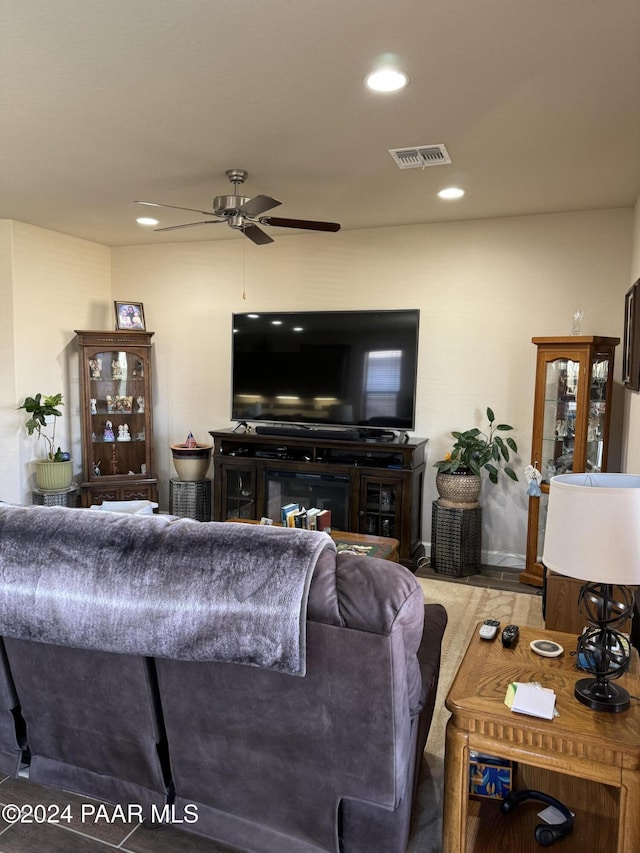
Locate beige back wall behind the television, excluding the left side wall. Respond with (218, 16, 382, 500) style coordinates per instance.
(112, 210, 633, 566)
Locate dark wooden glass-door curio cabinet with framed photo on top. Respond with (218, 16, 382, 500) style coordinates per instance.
(76, 330, 158, 507)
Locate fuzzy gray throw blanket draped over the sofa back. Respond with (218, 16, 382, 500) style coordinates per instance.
(0, 505, 335, 675)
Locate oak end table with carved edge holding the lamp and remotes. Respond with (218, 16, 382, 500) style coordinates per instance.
(443, 627, 640, 853)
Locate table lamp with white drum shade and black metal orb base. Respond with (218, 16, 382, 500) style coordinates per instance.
(542, 473, 640, 713)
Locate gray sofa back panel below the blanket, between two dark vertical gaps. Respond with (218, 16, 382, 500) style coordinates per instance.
(4, 637, 169, 814)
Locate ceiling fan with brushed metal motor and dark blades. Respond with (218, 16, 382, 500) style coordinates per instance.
(135, 169, 340, 246)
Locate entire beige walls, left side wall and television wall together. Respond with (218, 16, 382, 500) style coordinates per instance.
(0, 210, 640, 566)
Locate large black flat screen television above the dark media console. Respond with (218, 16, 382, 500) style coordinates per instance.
(231, 309, 420, 430)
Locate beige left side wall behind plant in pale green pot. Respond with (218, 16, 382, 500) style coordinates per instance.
(0, 221, 113, 503)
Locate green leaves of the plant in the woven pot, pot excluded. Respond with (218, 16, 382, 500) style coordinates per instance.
(434, 407, 518, 483)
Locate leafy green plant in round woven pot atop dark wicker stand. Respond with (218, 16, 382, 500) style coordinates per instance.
(434, 407, 518, 506)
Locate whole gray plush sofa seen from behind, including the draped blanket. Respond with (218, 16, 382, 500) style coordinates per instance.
(0, 505, 446, 853)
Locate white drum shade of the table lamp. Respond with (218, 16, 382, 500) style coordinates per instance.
(542, 474, 640, 586)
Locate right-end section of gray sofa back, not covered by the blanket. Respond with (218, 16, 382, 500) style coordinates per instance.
(157, 555, 424, 853)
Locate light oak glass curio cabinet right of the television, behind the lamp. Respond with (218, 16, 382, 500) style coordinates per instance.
(520, 335, 620, 586)
